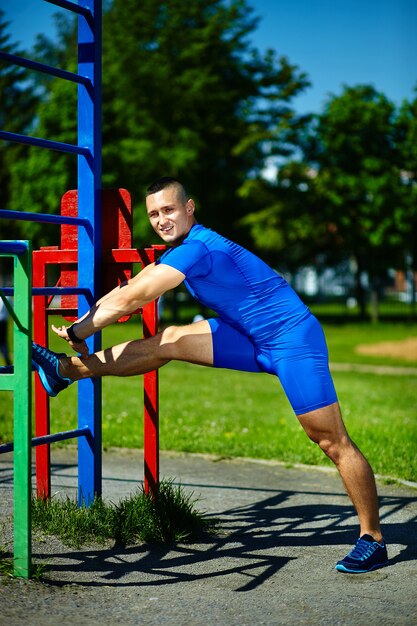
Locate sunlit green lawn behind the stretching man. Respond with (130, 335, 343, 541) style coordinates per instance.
(0, 322, 417, 481)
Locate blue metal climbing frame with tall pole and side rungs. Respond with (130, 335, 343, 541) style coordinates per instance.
(0, 0, 102, 505)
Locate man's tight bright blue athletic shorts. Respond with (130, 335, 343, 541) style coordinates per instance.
(208, 315, 337, 415)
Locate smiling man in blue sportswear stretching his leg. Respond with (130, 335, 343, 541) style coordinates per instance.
(32, 178, 388, 573)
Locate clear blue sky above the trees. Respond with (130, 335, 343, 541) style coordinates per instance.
(0, 0, 417, 113)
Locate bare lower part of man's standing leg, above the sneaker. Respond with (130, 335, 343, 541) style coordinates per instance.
(298, 402, 382, 542)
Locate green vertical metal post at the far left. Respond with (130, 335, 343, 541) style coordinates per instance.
(13, 242, 32, 578)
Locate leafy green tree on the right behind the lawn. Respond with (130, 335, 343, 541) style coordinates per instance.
(241, 85, 417, 315)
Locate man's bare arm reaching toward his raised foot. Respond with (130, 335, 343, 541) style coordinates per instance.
(52, 263, 185, 353)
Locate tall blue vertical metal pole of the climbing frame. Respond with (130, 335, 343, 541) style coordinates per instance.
(78, 0, 101, 505)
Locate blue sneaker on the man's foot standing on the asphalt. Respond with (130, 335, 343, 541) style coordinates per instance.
(336, 535, 388, 574)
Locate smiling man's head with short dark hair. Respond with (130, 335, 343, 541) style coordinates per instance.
(146, 185, 196, 246)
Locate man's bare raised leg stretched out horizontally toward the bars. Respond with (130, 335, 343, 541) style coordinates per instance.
(59, 320, 213, 381)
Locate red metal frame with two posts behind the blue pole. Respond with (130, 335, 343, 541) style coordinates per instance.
(33, 190, 165, 498)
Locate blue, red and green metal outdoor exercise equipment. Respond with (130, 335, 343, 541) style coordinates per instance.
(0, 0, 163, 577)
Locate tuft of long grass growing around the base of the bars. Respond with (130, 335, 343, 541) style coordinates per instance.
(32, 481, 213, 548)
